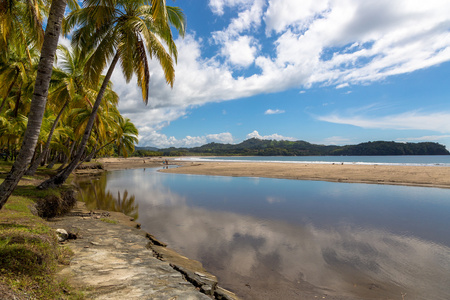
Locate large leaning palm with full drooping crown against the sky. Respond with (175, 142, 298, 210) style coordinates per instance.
(39, 0, 185, 189)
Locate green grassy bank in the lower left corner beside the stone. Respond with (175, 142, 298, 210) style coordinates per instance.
(0, 161, 83, 299)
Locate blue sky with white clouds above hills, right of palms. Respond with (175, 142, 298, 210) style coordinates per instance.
(108, 0, 450, 150)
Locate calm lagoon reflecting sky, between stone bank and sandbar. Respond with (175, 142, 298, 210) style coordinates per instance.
(75, 169, 450, 299)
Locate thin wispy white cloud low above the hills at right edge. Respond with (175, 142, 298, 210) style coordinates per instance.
(316, 111, 450, 133)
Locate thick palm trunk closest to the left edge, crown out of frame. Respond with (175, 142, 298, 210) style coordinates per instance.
(0, 0, 66, 209)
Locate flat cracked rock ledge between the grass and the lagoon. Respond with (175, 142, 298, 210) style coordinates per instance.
(50, 202, 239, 300)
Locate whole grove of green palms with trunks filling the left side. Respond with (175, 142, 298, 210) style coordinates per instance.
(0, 0, 186, 209)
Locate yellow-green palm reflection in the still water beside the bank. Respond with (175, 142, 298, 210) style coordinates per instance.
(77, 176, 139, 220)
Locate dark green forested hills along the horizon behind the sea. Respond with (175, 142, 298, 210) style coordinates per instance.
(133, 138, 450, 156)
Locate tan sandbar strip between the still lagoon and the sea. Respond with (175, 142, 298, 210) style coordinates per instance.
(157, 162, 450, 188)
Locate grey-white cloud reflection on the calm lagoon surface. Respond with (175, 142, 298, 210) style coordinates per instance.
(102, 172, 450, 299)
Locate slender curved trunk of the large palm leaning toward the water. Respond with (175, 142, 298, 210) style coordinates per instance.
(38, 53, 119, 189)
